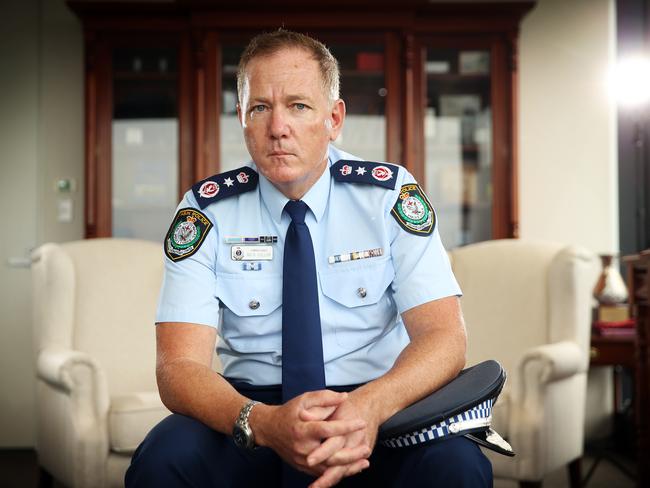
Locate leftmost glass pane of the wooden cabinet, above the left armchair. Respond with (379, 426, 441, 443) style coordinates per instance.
(111, 47, 179, 241)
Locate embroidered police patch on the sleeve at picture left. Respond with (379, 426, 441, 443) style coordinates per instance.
(165, 208, 212, 261)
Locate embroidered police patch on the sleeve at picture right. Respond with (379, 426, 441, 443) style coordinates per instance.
(390, 183, 436, 236)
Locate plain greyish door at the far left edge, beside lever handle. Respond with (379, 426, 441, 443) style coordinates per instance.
(0, 1, 39, 446)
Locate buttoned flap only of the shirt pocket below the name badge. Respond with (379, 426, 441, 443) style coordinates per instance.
(215, 273, 282, 317)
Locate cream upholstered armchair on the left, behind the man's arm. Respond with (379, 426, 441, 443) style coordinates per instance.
(32, 239, 169, 488)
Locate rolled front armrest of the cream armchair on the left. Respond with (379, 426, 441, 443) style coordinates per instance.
(36, 347, 110, 417)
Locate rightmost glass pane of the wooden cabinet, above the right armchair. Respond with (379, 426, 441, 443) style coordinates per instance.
(423, 47, 493, 249)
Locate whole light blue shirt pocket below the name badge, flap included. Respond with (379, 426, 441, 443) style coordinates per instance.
(215, 273, 282, 353)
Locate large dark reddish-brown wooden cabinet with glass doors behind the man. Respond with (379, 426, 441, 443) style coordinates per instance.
(68, 0, 534, 241)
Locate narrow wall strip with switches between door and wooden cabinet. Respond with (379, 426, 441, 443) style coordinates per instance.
(38, 0, 84, 244)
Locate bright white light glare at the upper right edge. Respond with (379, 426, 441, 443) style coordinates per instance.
(609, 56, 650, 107)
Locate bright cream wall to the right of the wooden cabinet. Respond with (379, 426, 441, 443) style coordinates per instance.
(519, 0, 618, 253)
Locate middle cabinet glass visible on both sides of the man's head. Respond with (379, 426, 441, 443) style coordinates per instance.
(219, 36, 387, 171)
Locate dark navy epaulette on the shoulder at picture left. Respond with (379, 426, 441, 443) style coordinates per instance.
(192, 166, 259, 210)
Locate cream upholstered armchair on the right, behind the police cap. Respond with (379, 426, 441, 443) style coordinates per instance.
(450, 239, 600, 486)
